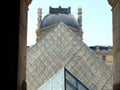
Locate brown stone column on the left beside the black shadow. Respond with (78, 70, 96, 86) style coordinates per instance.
(17, 0, 31, 90)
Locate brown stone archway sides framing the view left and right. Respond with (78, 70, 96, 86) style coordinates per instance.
(17, 0, 120, 90)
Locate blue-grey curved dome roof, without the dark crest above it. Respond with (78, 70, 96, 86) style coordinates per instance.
(40, 14, 80, 30)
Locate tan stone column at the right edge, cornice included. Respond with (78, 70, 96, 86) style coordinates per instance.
(108, 0, 120, 90)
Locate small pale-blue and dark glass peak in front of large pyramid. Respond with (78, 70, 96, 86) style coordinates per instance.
(38, 67, 89, 90)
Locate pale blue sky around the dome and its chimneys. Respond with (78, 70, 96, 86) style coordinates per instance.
(27, 0, 113, 46)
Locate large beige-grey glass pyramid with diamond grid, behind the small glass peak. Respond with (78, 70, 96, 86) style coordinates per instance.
(26, 22, 113, 90)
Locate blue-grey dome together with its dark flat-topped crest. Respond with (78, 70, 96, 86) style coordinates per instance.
(39, 7, 81, 30)
